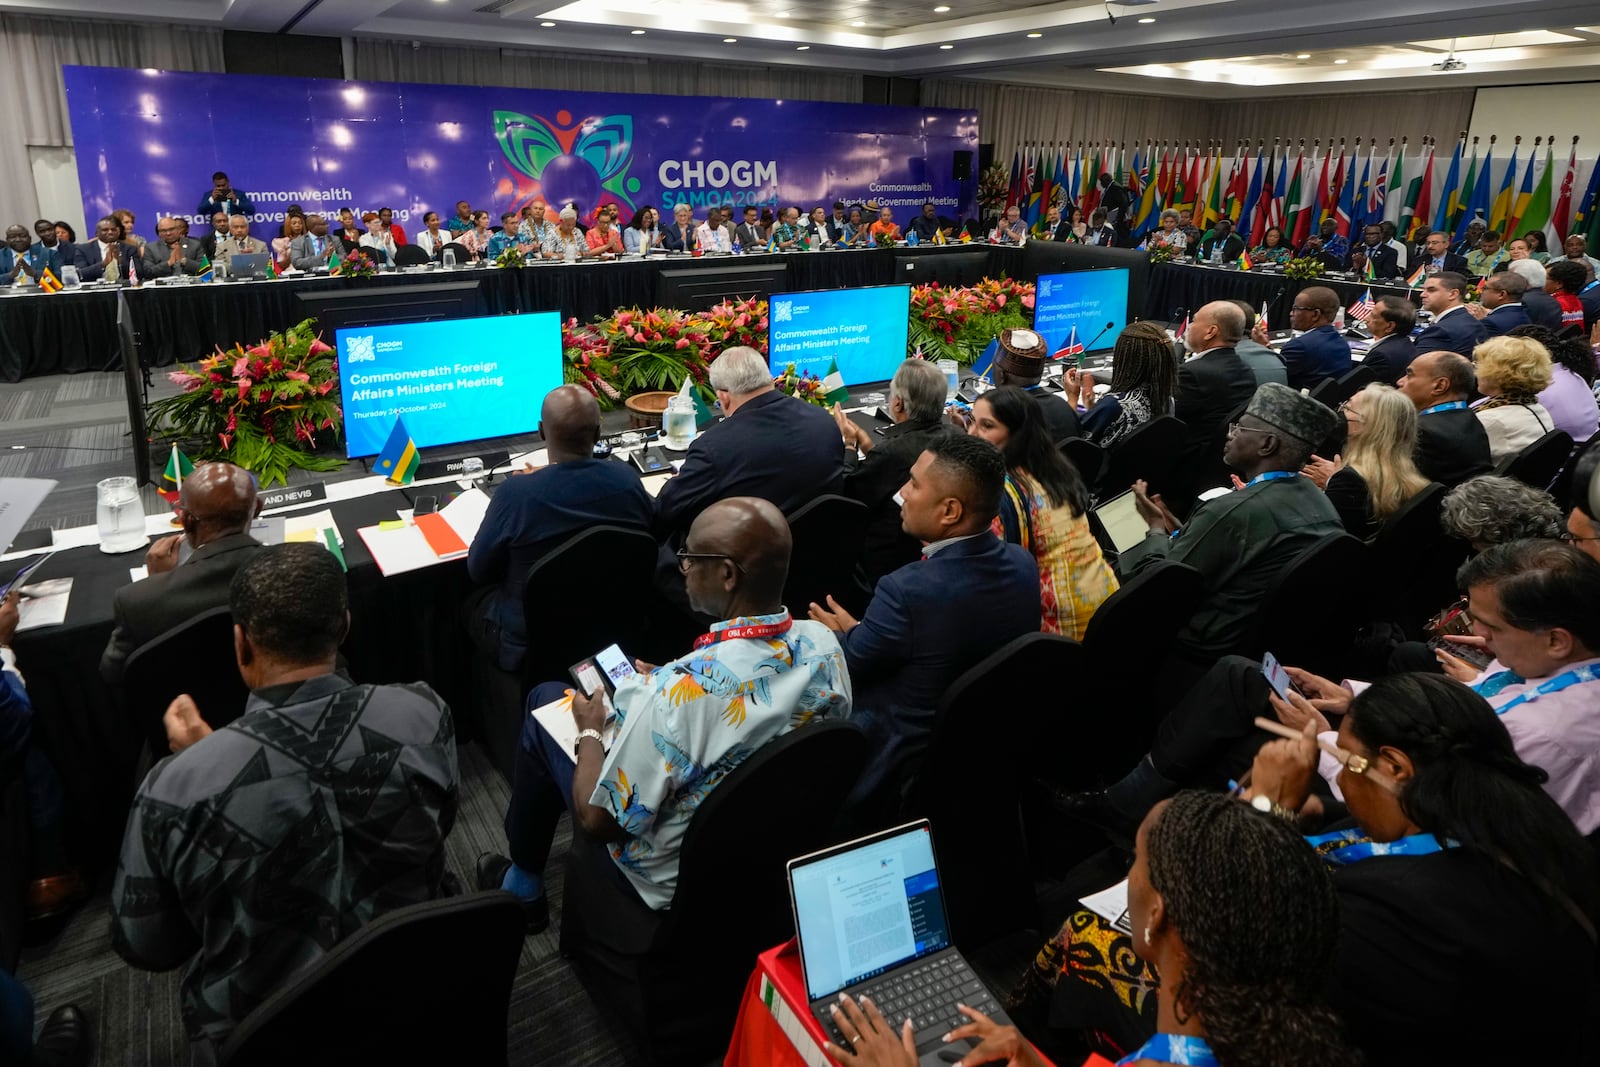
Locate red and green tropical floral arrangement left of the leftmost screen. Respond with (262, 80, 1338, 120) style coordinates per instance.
(150, 318, 344, 485)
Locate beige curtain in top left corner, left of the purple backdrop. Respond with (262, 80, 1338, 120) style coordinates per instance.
(0, 14, 222, 224)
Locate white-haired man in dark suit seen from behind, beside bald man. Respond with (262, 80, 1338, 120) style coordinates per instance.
(654, 347, 845, 550)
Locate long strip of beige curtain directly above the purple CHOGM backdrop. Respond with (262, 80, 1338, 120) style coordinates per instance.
(350, 40, 861, 102)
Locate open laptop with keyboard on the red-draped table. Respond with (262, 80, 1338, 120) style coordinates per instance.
(789, 819, 1011, 1067)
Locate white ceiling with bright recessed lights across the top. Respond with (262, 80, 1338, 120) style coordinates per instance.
(12, 0, 1600, 98)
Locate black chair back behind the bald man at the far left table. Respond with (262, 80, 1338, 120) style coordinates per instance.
(122, 605, 250, 760)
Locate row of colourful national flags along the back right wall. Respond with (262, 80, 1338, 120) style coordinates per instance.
(1005, 136, 1600, 254)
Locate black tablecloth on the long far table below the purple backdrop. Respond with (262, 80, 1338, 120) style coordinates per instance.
(0, 242, 1070, 382)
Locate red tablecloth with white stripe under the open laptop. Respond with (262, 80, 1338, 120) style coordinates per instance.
(722, 941, 1088, 1067)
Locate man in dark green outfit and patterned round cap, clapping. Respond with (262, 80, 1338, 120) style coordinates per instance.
(1117, 382, 1344, 657)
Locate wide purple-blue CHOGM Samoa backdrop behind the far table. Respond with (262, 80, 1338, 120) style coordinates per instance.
(62, 66, 978, 237)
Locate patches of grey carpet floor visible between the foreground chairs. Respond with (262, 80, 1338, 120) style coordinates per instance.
(18, 744, 642, 1067)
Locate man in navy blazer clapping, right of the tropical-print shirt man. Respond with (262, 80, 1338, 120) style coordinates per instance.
(810, 434, 1038, 816)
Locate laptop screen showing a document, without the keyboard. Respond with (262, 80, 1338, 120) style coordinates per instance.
(789, 821, 950, 1000)
